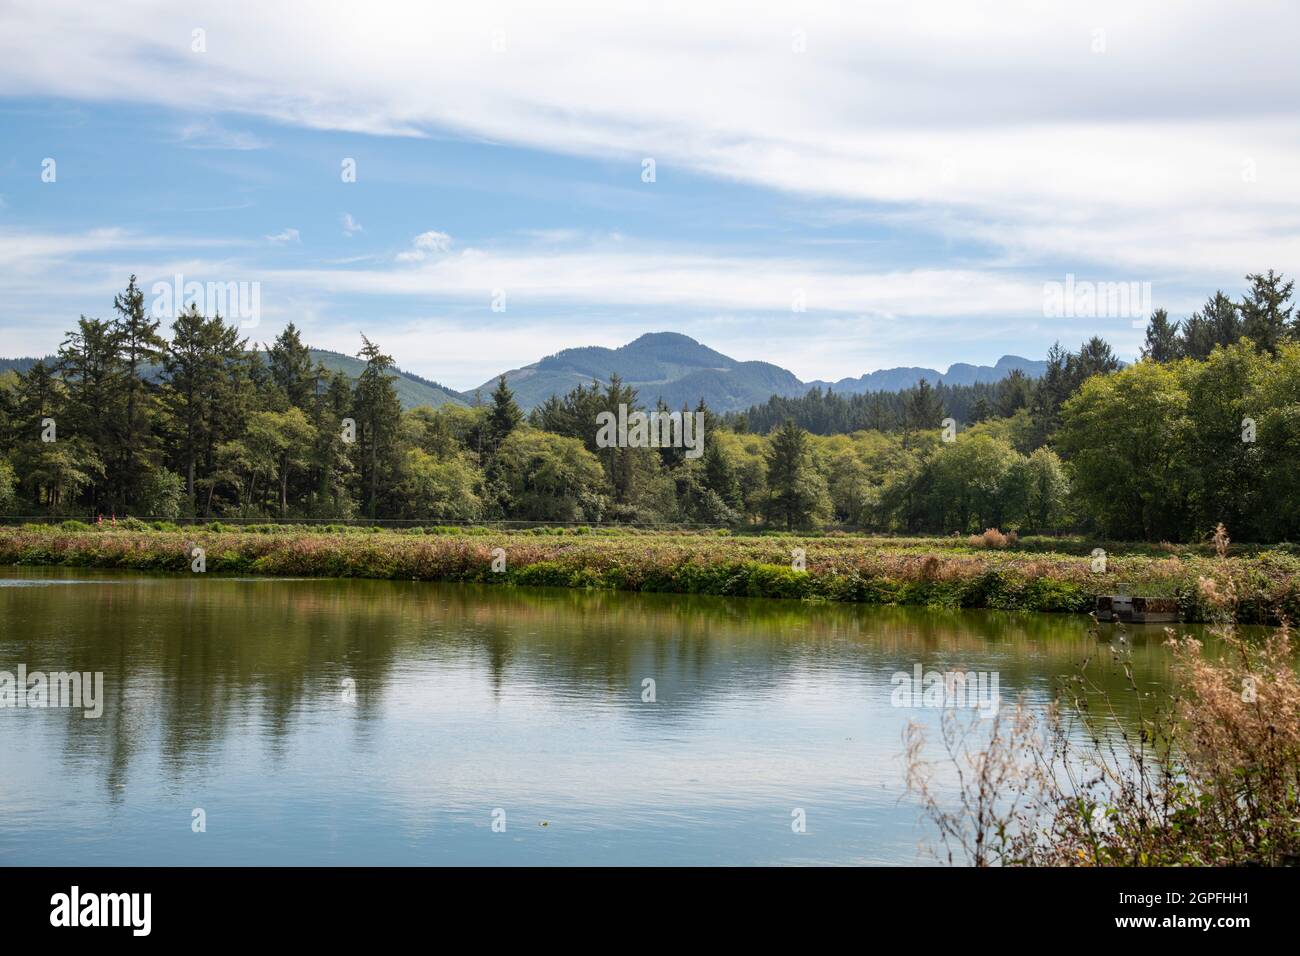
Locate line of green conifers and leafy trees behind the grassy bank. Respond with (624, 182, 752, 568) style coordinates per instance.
(0, 272, 1300, 541)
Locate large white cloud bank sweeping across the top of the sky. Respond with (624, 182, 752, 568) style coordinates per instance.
(0, 0, 1300, 273)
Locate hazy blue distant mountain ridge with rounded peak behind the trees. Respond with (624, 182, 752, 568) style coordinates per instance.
(478, 332, 1047, 411)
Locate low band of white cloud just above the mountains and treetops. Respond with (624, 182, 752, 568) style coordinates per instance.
(0, 229, 1073, 388)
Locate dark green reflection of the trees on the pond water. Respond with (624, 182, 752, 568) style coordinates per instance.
(0, 576, 1227, 799)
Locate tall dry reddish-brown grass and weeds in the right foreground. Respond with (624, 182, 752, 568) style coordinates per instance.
(906, 554, 1300, 866)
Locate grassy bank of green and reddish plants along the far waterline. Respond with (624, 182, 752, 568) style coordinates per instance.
(0, 523, 1300, 623)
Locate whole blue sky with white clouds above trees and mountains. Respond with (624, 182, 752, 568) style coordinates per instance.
(0, 0, 1300, 388)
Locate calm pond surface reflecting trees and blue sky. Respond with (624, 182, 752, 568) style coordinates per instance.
(0, 568, 1211, 865)
